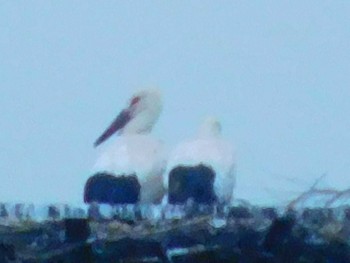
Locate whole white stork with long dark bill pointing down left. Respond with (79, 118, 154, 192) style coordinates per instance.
(84, 89, 165, 203)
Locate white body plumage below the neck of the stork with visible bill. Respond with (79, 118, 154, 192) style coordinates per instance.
(94, 134, 166, 203)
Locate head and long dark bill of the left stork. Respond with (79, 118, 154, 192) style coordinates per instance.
(94, 88, 162, 147)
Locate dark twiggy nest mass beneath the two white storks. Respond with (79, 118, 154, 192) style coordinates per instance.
(0, 204, 350, 263)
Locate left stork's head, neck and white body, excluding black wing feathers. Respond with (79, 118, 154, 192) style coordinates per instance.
(93, 89, 166, 203)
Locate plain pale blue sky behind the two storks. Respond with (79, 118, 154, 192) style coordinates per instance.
(0, 0, 350, 206)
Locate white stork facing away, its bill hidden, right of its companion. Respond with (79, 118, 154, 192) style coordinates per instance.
(163, 117, 235, 206)
